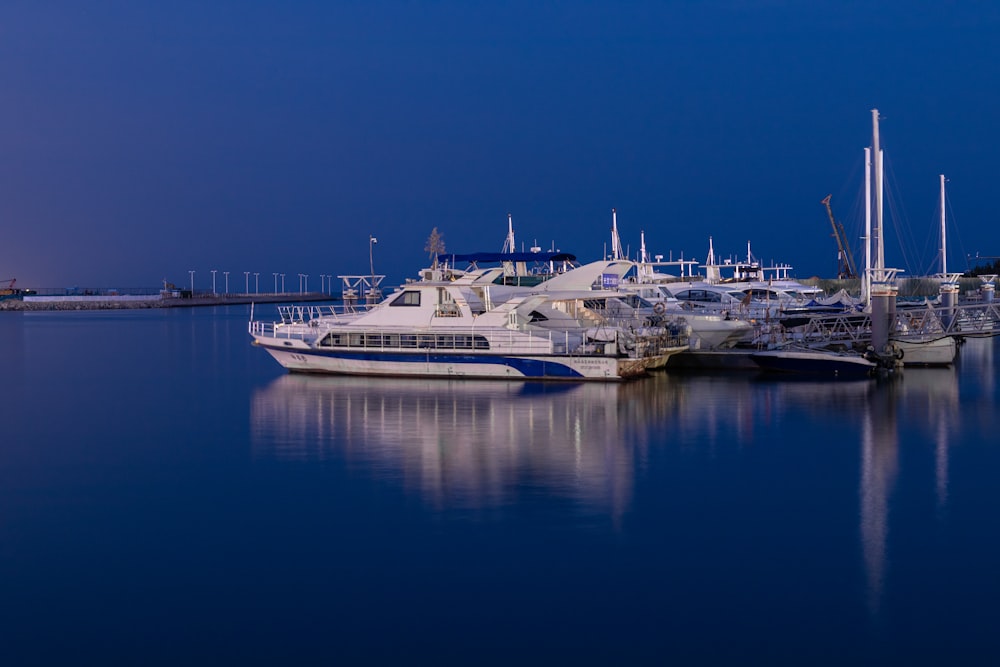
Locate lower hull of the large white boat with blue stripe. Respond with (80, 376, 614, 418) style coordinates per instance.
(255, 338, 685, 381)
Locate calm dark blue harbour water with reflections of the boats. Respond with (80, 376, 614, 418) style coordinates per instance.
(0, 307, 1000, 665)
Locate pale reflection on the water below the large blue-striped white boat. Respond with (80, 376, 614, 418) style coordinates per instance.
(251, 375, 672, 516)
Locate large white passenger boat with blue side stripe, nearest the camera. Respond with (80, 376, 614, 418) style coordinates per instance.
(250, 262, 688, 380)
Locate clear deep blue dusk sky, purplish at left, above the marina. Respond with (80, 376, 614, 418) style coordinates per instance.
(0, 0, 1000, 291)
